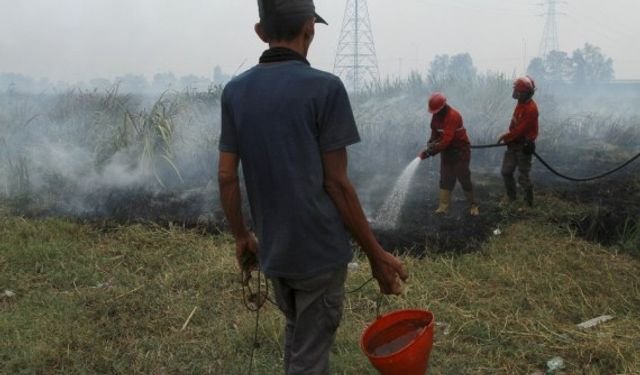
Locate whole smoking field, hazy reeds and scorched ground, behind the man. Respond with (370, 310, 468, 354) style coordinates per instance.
(0, 74, 640, 256)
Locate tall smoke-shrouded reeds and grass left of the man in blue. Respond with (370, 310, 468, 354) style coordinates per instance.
(0, 86, 221, 216)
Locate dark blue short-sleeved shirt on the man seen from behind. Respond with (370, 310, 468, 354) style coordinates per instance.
(219, 61, 360, 279)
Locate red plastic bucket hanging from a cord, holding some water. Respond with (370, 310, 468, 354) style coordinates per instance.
(360, 310, 435, 375)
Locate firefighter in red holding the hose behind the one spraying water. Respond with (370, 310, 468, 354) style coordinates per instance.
(498, 76, 538, 206)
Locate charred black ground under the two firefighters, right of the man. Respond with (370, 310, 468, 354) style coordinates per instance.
(364, 155, 640, 256)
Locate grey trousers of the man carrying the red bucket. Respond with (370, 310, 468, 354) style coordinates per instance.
(271, 265, 347, 375)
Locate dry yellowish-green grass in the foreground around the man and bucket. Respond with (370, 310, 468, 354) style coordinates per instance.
(0, 196, 640, 375)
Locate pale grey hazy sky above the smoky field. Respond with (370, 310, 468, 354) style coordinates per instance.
(0, 0, 640, 81)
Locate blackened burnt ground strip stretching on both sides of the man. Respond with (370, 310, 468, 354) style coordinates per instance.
(3, 154, 640, 257)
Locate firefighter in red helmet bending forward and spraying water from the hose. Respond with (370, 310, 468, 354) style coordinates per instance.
(418, 92, 480, 216)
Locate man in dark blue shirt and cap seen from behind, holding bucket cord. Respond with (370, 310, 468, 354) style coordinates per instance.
(218, 0, 407, 375)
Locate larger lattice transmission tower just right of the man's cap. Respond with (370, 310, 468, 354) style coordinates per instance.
(333, 0, 380, 92)
